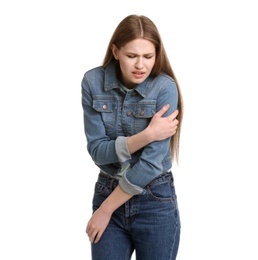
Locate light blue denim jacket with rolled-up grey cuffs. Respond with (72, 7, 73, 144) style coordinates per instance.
(81, 61, 178, 195)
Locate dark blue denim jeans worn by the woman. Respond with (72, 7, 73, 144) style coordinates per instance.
(91, 172, 180, 260)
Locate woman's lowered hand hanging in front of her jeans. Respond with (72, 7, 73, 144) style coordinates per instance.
(86, 206, 112, 244)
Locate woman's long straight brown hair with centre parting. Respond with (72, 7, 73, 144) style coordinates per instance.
(103, 15, 183, 162)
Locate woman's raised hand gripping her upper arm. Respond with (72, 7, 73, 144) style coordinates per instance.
(147, 104, 179, 141)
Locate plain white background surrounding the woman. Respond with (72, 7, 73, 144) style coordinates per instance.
(0, 0, 258, 260)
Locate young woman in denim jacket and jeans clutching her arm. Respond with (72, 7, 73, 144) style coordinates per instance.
(82, 15, 183, 260)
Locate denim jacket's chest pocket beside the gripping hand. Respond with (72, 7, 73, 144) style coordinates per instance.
(133, 100, 156, 133)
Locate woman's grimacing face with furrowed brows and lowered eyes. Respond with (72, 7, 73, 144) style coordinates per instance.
(112, 39, 156, 88)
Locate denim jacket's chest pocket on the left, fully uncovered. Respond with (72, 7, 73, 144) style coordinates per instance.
(93, 99, 117, 132)
